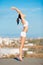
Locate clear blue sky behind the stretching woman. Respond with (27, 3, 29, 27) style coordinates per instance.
(0, 0, 43, 37)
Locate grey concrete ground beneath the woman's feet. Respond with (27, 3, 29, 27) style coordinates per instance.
(0, 58, 43, 65)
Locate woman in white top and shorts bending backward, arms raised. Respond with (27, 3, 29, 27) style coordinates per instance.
(11, 7, 28, 61)
